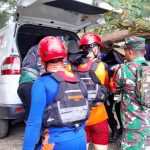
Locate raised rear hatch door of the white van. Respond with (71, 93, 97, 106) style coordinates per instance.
(15, 0, 107, 32)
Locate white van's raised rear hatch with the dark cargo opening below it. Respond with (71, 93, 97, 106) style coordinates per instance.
(15, 0, 107, 59)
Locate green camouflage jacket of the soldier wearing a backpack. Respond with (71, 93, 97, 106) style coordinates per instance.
(116, 57, 150, 134)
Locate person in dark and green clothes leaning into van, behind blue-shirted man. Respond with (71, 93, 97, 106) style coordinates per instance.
(17, 37, 45, 118)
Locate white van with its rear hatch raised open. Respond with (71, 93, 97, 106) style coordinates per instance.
(0, 0, 106, 138)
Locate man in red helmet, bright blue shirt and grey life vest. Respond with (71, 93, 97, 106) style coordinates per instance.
(23, 36, 89, 150)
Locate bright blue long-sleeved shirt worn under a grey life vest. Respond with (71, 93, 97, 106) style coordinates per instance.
(23, 75, 85, 150)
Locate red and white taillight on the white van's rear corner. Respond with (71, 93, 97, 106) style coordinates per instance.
(1, 56, 21, 75)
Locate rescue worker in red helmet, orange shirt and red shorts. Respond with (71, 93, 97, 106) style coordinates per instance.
(67, 32, 109, 150)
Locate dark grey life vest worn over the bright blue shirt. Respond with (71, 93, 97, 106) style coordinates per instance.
(43, 73, 89, 128)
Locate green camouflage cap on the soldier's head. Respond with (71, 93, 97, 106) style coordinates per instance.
(124, 36, 145, 50)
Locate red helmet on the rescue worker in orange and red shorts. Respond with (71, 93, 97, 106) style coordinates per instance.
(79, 32, 104, 49)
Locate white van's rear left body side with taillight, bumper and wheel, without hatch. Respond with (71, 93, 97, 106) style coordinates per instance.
(0, 23, 25, 138)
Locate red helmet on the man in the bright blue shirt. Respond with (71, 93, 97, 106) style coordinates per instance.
(39, 36, 67, 62)
